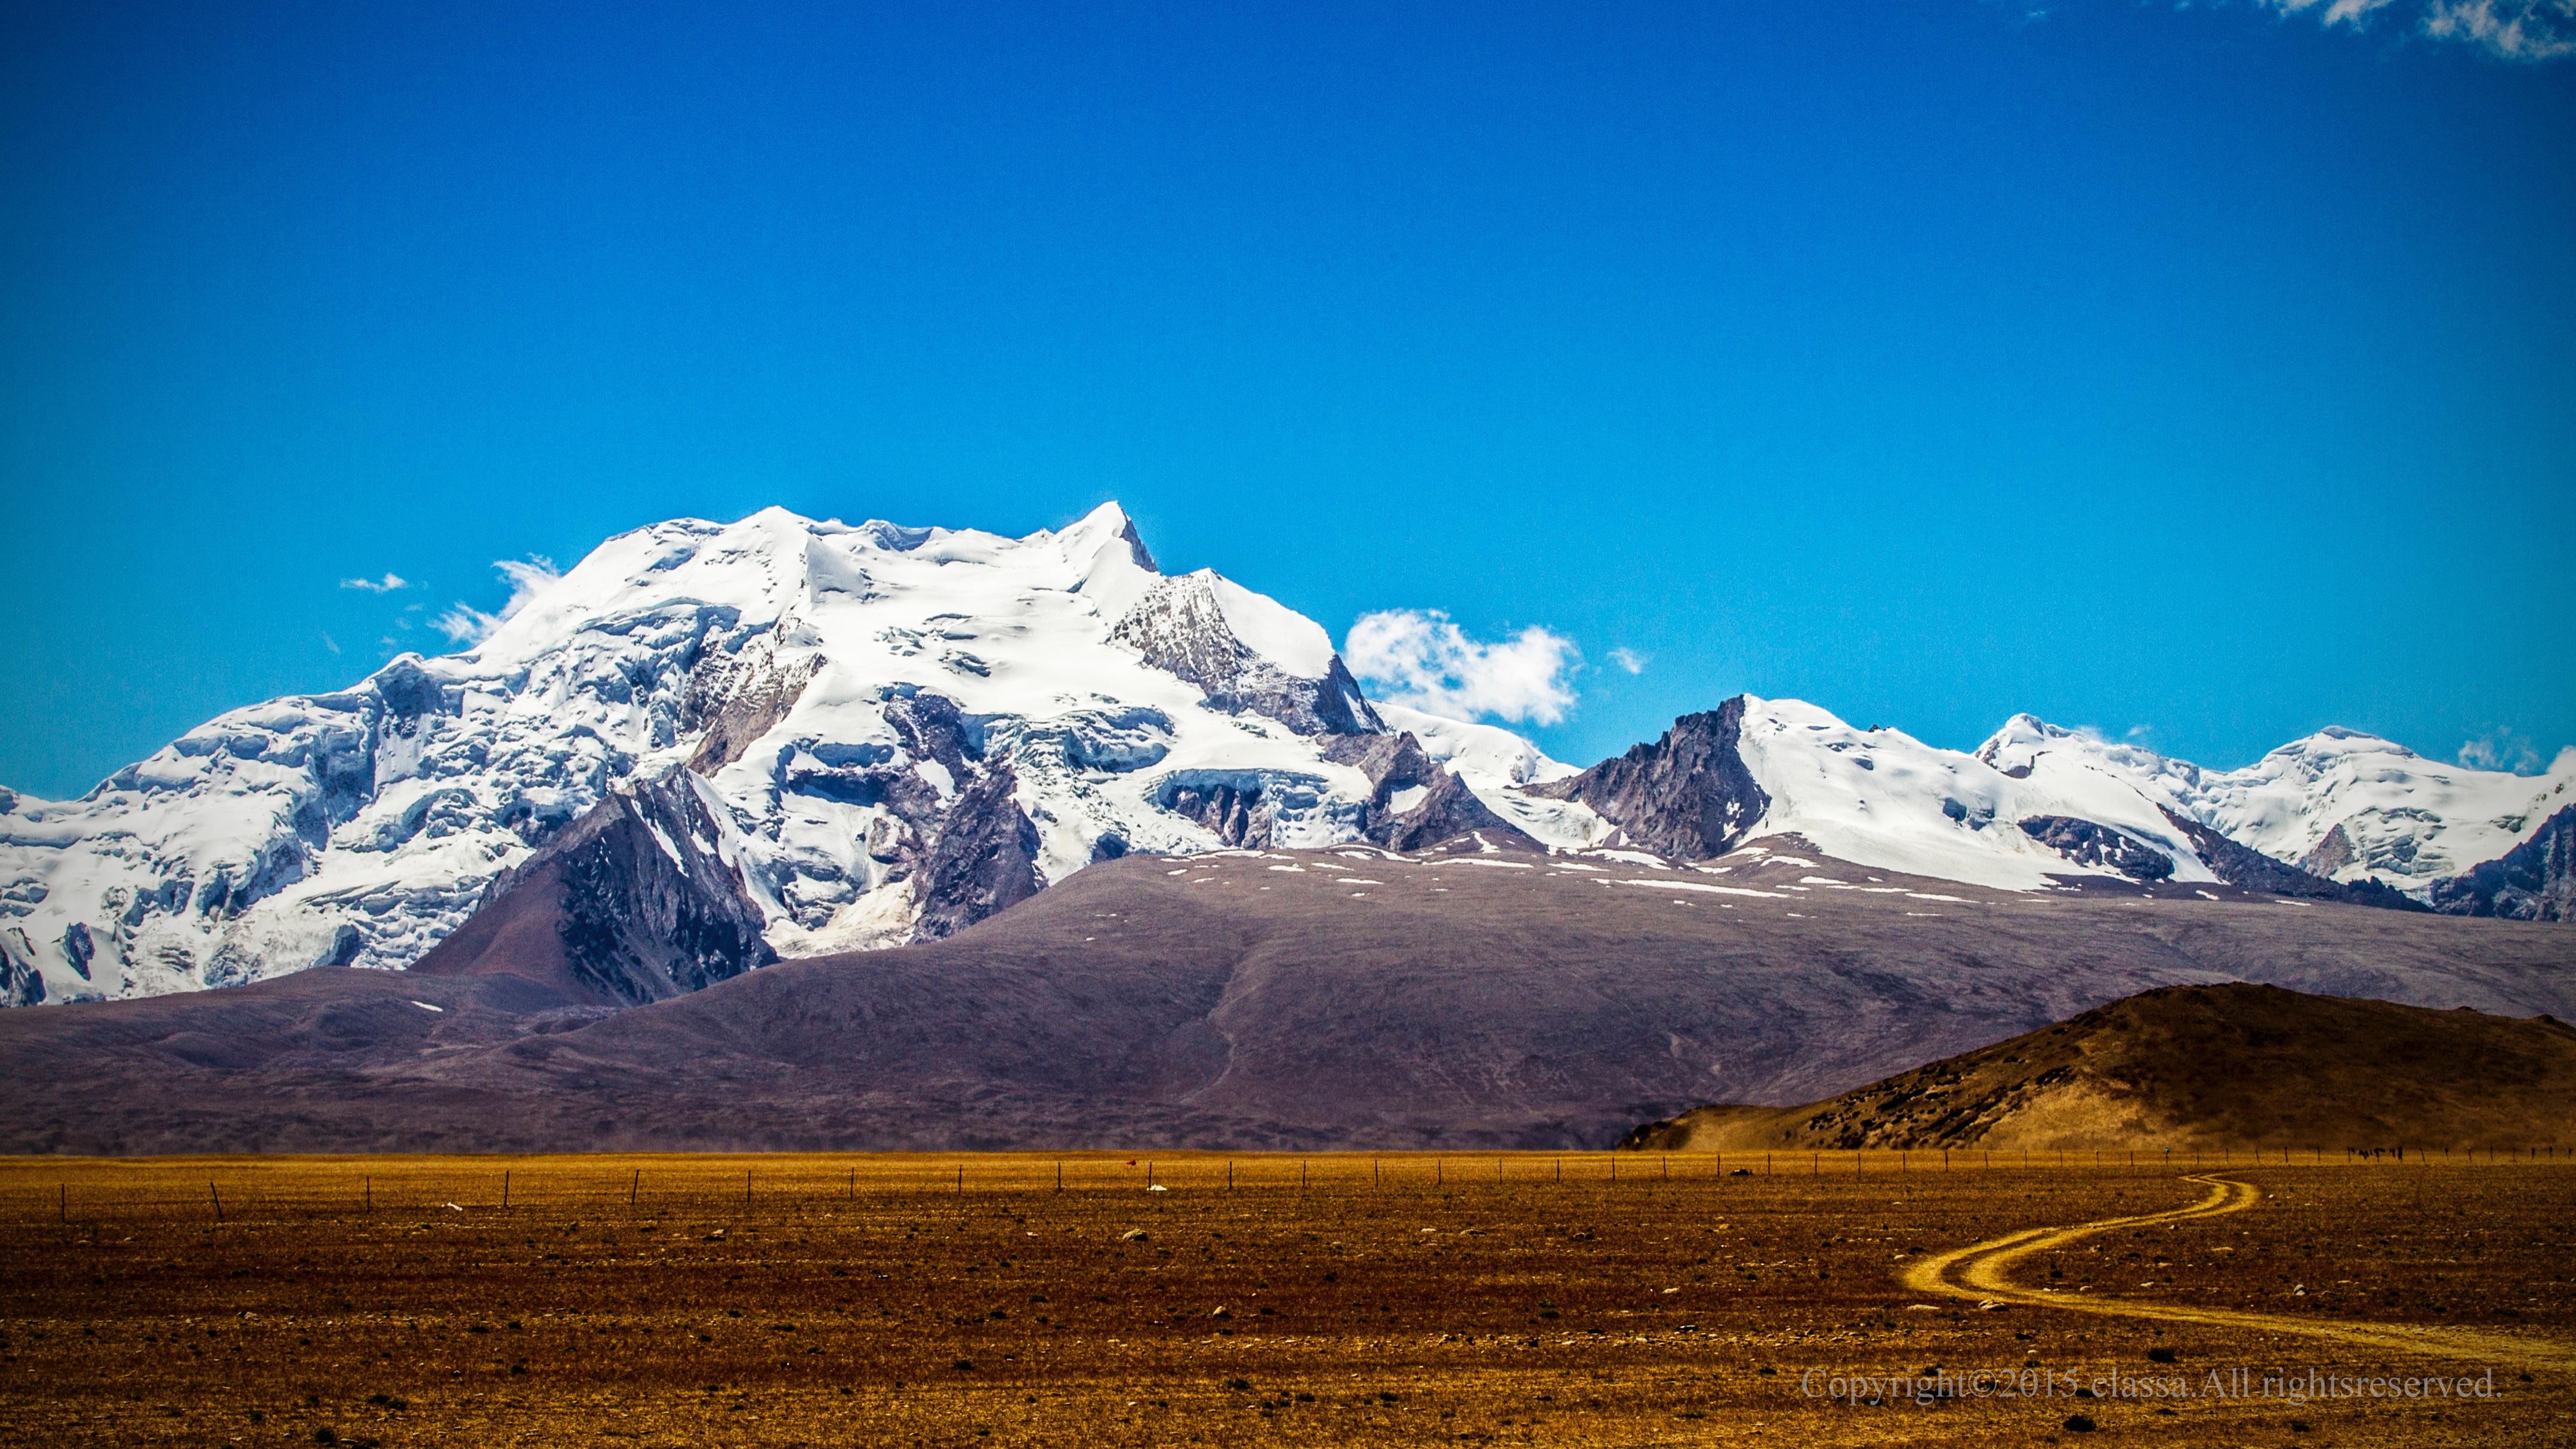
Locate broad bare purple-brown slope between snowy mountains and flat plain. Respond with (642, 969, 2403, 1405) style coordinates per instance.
(0, 838, 2576, 1152)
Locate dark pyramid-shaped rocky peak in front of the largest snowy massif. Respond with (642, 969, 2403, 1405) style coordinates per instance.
(415, 773, 778, 1006)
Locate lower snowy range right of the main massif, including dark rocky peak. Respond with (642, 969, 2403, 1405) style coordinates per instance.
(1479, 696, 2576, 920)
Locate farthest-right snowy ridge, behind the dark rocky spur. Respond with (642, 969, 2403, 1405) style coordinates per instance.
(1976, 714, 2576, 895)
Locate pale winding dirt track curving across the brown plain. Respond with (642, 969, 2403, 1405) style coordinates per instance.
(1899, 1173, 2576, 1369)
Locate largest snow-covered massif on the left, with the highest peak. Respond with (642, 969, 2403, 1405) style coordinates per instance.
(0, 505, 1514, 1000)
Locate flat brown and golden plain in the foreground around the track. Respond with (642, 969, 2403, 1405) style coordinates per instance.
(0, 1152, 2576, 1447)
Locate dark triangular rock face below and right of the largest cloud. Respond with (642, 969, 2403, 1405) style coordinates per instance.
(1528, 696, 1770, 861)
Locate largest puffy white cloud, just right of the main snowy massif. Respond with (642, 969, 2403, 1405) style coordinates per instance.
(1342, 609, 1582, 724)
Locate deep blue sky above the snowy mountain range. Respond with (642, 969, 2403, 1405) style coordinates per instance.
(0, 0, 2576, 794)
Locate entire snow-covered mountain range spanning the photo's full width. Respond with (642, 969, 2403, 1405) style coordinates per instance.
(0, 495, 2576, 1006)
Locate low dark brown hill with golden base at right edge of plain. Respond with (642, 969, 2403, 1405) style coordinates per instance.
(1623, 982, 2576, 1152)
